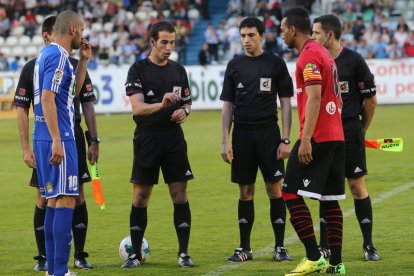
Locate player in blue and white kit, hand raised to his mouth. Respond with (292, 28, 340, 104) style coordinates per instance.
(33, 11, 91, 276)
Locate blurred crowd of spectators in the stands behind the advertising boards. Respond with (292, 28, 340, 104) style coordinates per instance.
(0, 0, 414, 71)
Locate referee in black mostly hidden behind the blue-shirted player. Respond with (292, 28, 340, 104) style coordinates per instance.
(13, 16, 100, 271)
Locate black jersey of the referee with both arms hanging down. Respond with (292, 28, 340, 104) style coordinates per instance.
(220, 51, 293, 128)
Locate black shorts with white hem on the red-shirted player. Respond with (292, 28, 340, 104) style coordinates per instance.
(282, 140, 345, 200)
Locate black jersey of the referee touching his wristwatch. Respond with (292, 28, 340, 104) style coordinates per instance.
(125, 58, 192, 130)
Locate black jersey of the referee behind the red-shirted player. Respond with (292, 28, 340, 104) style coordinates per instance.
(335, 47, 377, 120)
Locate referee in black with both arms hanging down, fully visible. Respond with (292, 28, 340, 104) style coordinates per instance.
(220, 17, 293, 263)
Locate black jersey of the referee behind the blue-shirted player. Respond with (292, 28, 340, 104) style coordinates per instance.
(13, 57, 96, 123)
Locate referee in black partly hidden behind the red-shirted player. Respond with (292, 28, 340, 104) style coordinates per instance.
(313, 14, 380, 261)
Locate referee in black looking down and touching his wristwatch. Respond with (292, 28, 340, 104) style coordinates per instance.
(122, 21, 193, 268)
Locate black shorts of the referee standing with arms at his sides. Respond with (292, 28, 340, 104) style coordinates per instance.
(231, 125, 285, 184)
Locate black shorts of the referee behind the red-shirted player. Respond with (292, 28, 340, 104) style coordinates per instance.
(342, 119, 368, 178)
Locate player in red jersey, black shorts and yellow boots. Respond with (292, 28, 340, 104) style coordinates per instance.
(281, 7, 345, 275)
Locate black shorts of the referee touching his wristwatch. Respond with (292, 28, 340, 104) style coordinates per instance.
(130, 127, 194, 185)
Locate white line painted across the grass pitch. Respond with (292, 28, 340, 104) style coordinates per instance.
(203, 182, 414, 276)
